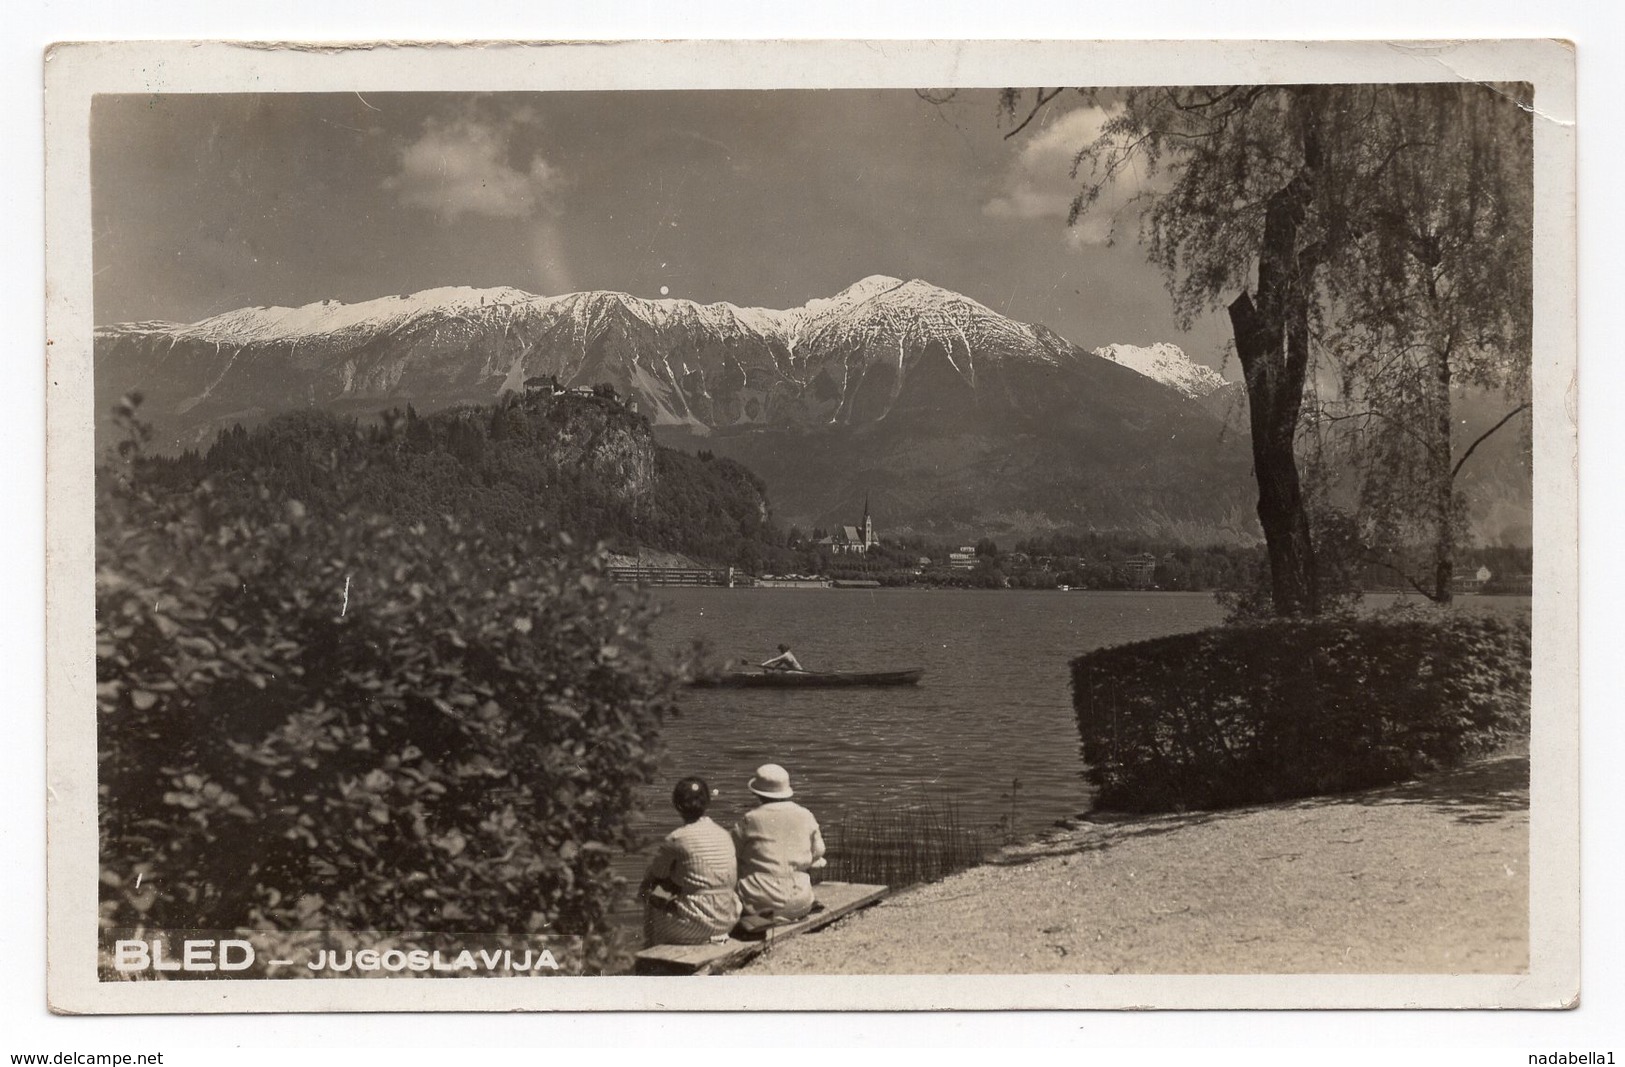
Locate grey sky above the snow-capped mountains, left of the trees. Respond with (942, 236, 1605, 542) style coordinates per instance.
(91, 89, 1235, 377)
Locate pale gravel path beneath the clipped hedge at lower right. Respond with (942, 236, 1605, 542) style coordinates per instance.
(746, 755, 1529, 974)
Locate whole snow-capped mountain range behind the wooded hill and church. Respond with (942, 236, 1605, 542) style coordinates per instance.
(96, 276, 1253, 536)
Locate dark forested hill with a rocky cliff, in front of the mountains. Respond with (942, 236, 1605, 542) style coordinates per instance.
(126, 391, 783, 570)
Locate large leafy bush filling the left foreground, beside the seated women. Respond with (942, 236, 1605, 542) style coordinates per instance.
(96, 415, 676, 971)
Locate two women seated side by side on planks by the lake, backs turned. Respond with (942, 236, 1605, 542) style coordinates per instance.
(639, 763, 824, 945)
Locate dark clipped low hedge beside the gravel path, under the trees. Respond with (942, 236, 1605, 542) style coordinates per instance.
(1073, 612, 1529, 812)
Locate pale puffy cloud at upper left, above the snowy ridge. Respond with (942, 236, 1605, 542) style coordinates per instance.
(384, 115, 562, 221)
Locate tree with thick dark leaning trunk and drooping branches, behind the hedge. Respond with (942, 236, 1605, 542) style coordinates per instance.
(1004, 84, 1518, 616)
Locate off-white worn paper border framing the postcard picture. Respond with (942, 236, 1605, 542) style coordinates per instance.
(44, 41, 1580, 1013)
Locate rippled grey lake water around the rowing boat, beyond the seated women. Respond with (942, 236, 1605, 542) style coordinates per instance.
(621, 588, 1529, 906)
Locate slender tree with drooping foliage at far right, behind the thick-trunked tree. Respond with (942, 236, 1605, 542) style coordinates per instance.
(1328, 86, 1534, 603)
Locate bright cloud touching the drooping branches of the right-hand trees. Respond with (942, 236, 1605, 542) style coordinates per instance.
(982, 107, 1144, 248)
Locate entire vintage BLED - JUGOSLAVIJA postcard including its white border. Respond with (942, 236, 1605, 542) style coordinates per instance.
(47, 41, 1580, 1012)
